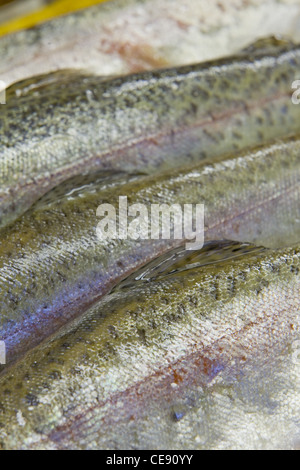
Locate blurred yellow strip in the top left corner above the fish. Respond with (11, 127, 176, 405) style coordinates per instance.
(0, 0, 107, 36)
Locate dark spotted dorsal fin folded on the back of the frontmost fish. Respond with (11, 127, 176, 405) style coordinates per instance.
(113, 240, 268, 291)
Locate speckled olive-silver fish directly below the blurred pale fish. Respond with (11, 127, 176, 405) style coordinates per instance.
(0, 40, 300, 226)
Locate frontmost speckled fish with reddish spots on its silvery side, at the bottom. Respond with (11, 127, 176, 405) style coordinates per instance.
(0, 246, 300, 450)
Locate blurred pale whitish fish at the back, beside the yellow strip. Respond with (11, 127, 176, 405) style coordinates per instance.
(0, 0, 300, 86)
